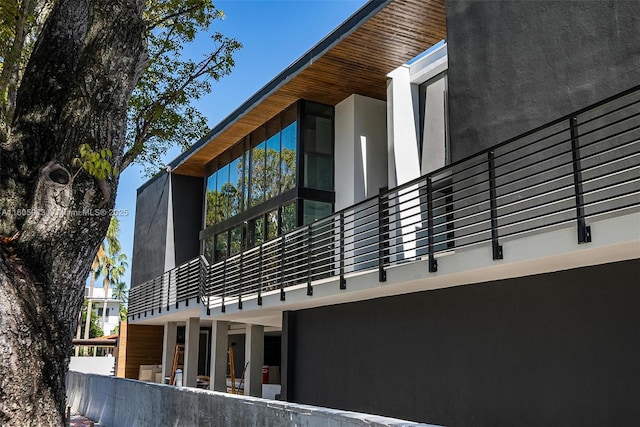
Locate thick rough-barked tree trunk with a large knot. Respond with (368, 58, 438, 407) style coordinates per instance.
(0, 0, 146, 426)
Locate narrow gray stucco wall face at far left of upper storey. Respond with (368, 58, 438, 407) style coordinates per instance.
(131, 174, 169, 287)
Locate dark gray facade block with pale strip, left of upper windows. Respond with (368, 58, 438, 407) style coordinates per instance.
(131, 173, 203, 287)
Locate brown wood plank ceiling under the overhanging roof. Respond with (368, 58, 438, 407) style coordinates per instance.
(174, 0, 446, 177)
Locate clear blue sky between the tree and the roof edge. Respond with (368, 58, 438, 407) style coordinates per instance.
(116, 0, 367, 290)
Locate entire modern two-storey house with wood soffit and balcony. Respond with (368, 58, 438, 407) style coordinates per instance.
(129, 0, 640, 426)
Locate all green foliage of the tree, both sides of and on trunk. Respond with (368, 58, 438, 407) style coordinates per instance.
(0, 0, 241, 174)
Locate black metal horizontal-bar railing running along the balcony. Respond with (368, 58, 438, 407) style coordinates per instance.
(129, 88, 640, 315)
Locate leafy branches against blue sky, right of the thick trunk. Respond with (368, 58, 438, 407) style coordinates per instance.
(124, 0, 241, 175)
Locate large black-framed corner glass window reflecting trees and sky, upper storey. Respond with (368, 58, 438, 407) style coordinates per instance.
(203, 101, 334, 262)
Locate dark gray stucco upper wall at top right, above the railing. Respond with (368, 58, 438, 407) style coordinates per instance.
(446, 0, 640, 161)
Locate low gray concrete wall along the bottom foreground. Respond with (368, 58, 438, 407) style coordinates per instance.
(67, 372, 440, 427)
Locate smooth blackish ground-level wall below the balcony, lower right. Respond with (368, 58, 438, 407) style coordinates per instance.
(282, 259, 640, 427)
